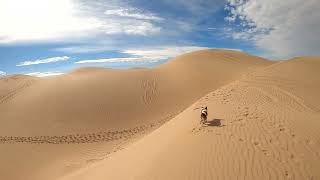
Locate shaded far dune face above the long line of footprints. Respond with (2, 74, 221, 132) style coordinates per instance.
(0, 50, 270, 135)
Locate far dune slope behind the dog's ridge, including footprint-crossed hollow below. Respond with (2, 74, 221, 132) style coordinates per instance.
(0, 50, 271, 180)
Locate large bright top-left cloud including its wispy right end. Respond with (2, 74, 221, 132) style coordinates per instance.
(0, 0, 160, 44)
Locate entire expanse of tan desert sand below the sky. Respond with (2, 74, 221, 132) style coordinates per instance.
(0, 50, 320, 180)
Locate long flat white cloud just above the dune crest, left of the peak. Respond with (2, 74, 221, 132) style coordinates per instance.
(76, 46, 208, 64)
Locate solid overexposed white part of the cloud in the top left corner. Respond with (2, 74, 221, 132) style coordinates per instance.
(0, 0, 102, 43)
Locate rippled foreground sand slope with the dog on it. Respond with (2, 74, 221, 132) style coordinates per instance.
(63, 58, 320, 180)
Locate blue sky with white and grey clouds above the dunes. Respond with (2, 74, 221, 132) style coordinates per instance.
(0, 0, 320, 77)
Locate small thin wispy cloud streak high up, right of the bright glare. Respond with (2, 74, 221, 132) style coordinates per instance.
(104, 8, 163, 20)
